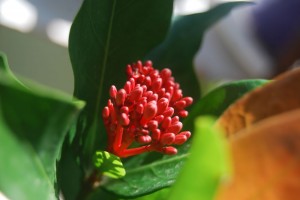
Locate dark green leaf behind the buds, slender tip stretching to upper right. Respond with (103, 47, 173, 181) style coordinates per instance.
(148, 2, 245, 101)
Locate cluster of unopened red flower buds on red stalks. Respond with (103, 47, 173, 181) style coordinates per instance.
(102, 61, 193, 157)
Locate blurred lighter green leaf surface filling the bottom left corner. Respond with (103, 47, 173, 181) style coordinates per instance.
(0, 115, 55, 199)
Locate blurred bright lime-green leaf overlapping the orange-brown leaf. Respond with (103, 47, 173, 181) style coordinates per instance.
(168, 117, 231, 200)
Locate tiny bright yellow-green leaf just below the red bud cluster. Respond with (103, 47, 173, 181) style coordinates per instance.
(94, 151, 126, 179)
